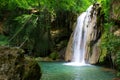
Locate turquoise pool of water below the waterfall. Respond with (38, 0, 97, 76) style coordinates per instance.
(39, 62, 115, 80)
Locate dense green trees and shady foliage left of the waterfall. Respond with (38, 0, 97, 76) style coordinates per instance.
(0, 0, 91, 56)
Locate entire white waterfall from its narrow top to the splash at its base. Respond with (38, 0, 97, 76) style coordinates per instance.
(65, 5, 93, 66)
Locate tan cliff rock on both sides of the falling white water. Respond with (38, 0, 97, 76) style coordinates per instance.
(65, 3, 103, 64)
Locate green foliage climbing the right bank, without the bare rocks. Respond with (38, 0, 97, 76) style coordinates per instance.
(100, 0, 120, 76)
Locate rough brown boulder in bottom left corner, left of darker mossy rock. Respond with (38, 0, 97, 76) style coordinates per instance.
(0, 47, 24, 80)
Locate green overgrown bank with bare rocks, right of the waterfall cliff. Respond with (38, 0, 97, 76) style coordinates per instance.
(100, 0, 120, 76)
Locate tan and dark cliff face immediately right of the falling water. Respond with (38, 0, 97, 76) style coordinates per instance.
(85, 4, 104, 64)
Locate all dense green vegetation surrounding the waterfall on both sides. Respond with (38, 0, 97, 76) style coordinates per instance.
(0, 0, 120, 75)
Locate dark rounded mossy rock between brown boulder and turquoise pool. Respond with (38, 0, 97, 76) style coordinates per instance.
(23, 58, 41, 80)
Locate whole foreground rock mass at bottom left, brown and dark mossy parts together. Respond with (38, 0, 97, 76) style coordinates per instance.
(0, 47, 41, 80)
